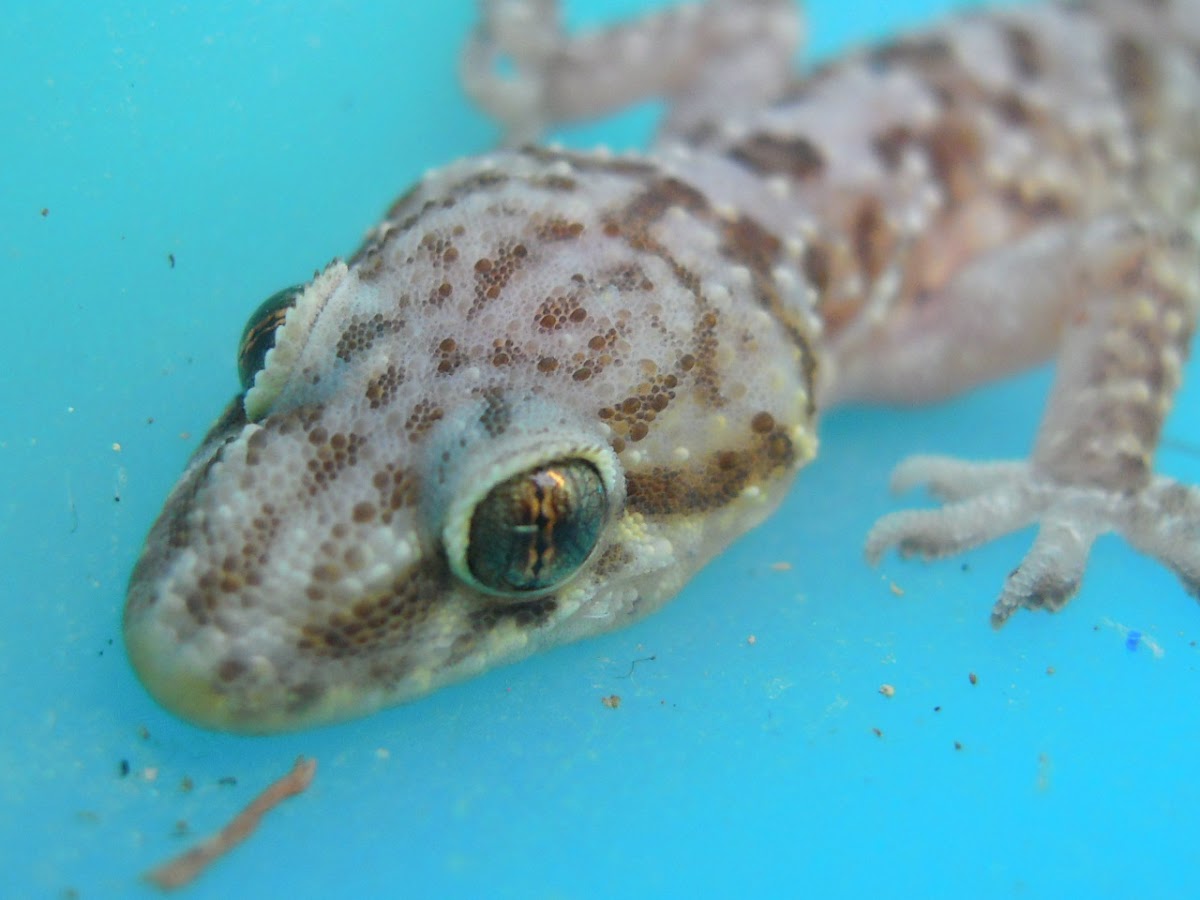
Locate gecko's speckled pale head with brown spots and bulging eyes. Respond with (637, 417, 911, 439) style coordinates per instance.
(125, 154, 811, 732)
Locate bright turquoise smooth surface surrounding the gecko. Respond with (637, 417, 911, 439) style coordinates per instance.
(0, 0, 1200, 898)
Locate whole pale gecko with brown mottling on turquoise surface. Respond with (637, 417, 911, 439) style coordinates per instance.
(125, 0, 1200, 732)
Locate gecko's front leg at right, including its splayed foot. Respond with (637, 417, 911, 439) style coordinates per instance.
(866, 218, 1200, 625)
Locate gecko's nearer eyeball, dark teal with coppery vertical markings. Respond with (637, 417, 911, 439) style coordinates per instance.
(467, 460, 607, 594)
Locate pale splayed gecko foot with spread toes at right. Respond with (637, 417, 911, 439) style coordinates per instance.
(866, 456, 1200, 626)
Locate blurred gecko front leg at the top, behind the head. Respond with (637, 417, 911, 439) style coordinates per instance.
(461, 0, 800, 145)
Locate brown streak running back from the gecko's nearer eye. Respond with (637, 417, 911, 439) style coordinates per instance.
(625, 428, 796, 516)
